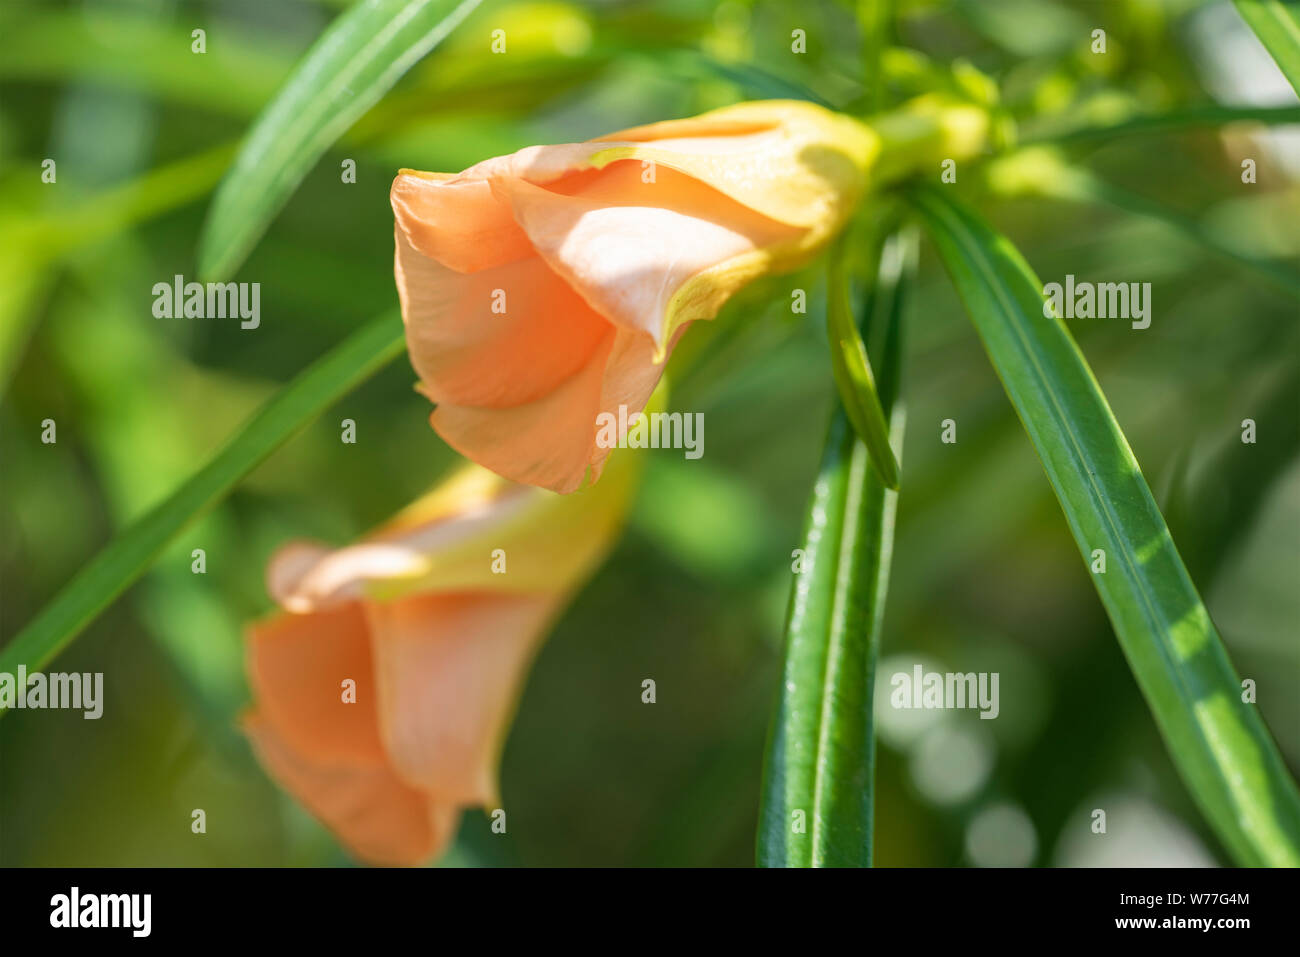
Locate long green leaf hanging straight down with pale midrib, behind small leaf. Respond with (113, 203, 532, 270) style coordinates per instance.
(758, 234, 904, 867)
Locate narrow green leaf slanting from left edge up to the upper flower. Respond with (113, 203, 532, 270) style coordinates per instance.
(0, 313, 404, 686)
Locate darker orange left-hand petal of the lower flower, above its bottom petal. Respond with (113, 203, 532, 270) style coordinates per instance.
(247, 603, 384, 765)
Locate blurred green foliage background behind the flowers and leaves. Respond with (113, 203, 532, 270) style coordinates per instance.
(0, 0, 1300, 866)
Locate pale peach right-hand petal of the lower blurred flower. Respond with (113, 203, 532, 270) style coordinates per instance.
(367, 594, 559, 806)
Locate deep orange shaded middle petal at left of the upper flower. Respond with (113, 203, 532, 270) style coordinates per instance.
(395, 229, 608, 407)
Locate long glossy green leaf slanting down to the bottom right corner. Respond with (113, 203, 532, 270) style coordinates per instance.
(913, 189, 1300, 866)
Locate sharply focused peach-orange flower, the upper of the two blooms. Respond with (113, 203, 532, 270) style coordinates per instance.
(391, 101, 879, 493)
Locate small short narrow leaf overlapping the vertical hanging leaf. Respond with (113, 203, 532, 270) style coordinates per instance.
(826, 246, 898, 489)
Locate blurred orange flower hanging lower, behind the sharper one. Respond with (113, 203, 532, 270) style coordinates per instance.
(244, 444, 634, 865)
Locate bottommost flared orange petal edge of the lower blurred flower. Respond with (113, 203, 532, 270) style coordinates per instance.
(243, 713, 460, 865)
